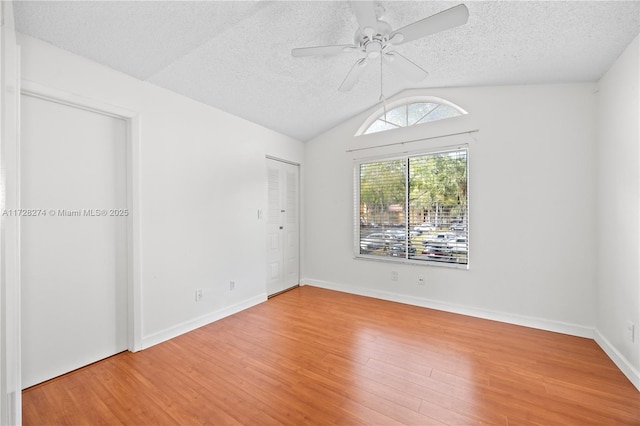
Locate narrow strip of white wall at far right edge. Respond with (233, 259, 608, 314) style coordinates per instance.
(596, 37, 640, 389)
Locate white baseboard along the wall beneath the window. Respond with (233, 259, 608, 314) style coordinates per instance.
(303, 279, 593, 339)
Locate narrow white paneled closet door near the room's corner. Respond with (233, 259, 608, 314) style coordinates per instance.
(267, 159, 300, 295)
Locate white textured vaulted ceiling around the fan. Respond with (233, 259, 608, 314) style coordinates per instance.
(14, 1, 640, 141)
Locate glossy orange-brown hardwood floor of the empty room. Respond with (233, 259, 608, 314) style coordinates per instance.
(23, 286, 640, 425)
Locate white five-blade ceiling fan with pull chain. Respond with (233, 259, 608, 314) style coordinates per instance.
(291, 1, 469, 92)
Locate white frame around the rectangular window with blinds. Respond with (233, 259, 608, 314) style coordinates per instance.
(352, 144, 471, 270)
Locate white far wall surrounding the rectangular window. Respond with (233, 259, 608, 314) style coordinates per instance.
(303, 84, 597, 337)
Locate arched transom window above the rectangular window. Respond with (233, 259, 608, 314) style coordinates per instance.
(357, 97, 467, 135)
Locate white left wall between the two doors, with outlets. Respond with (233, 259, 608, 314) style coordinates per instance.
(19, 36, 304, 347)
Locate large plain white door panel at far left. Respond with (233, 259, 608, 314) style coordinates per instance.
(20, 95, 129, 388)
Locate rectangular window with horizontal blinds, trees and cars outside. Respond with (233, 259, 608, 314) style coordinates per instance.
(355, 148, 469, 268)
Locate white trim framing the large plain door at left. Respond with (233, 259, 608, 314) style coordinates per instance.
(16, 80, 142, 352)
